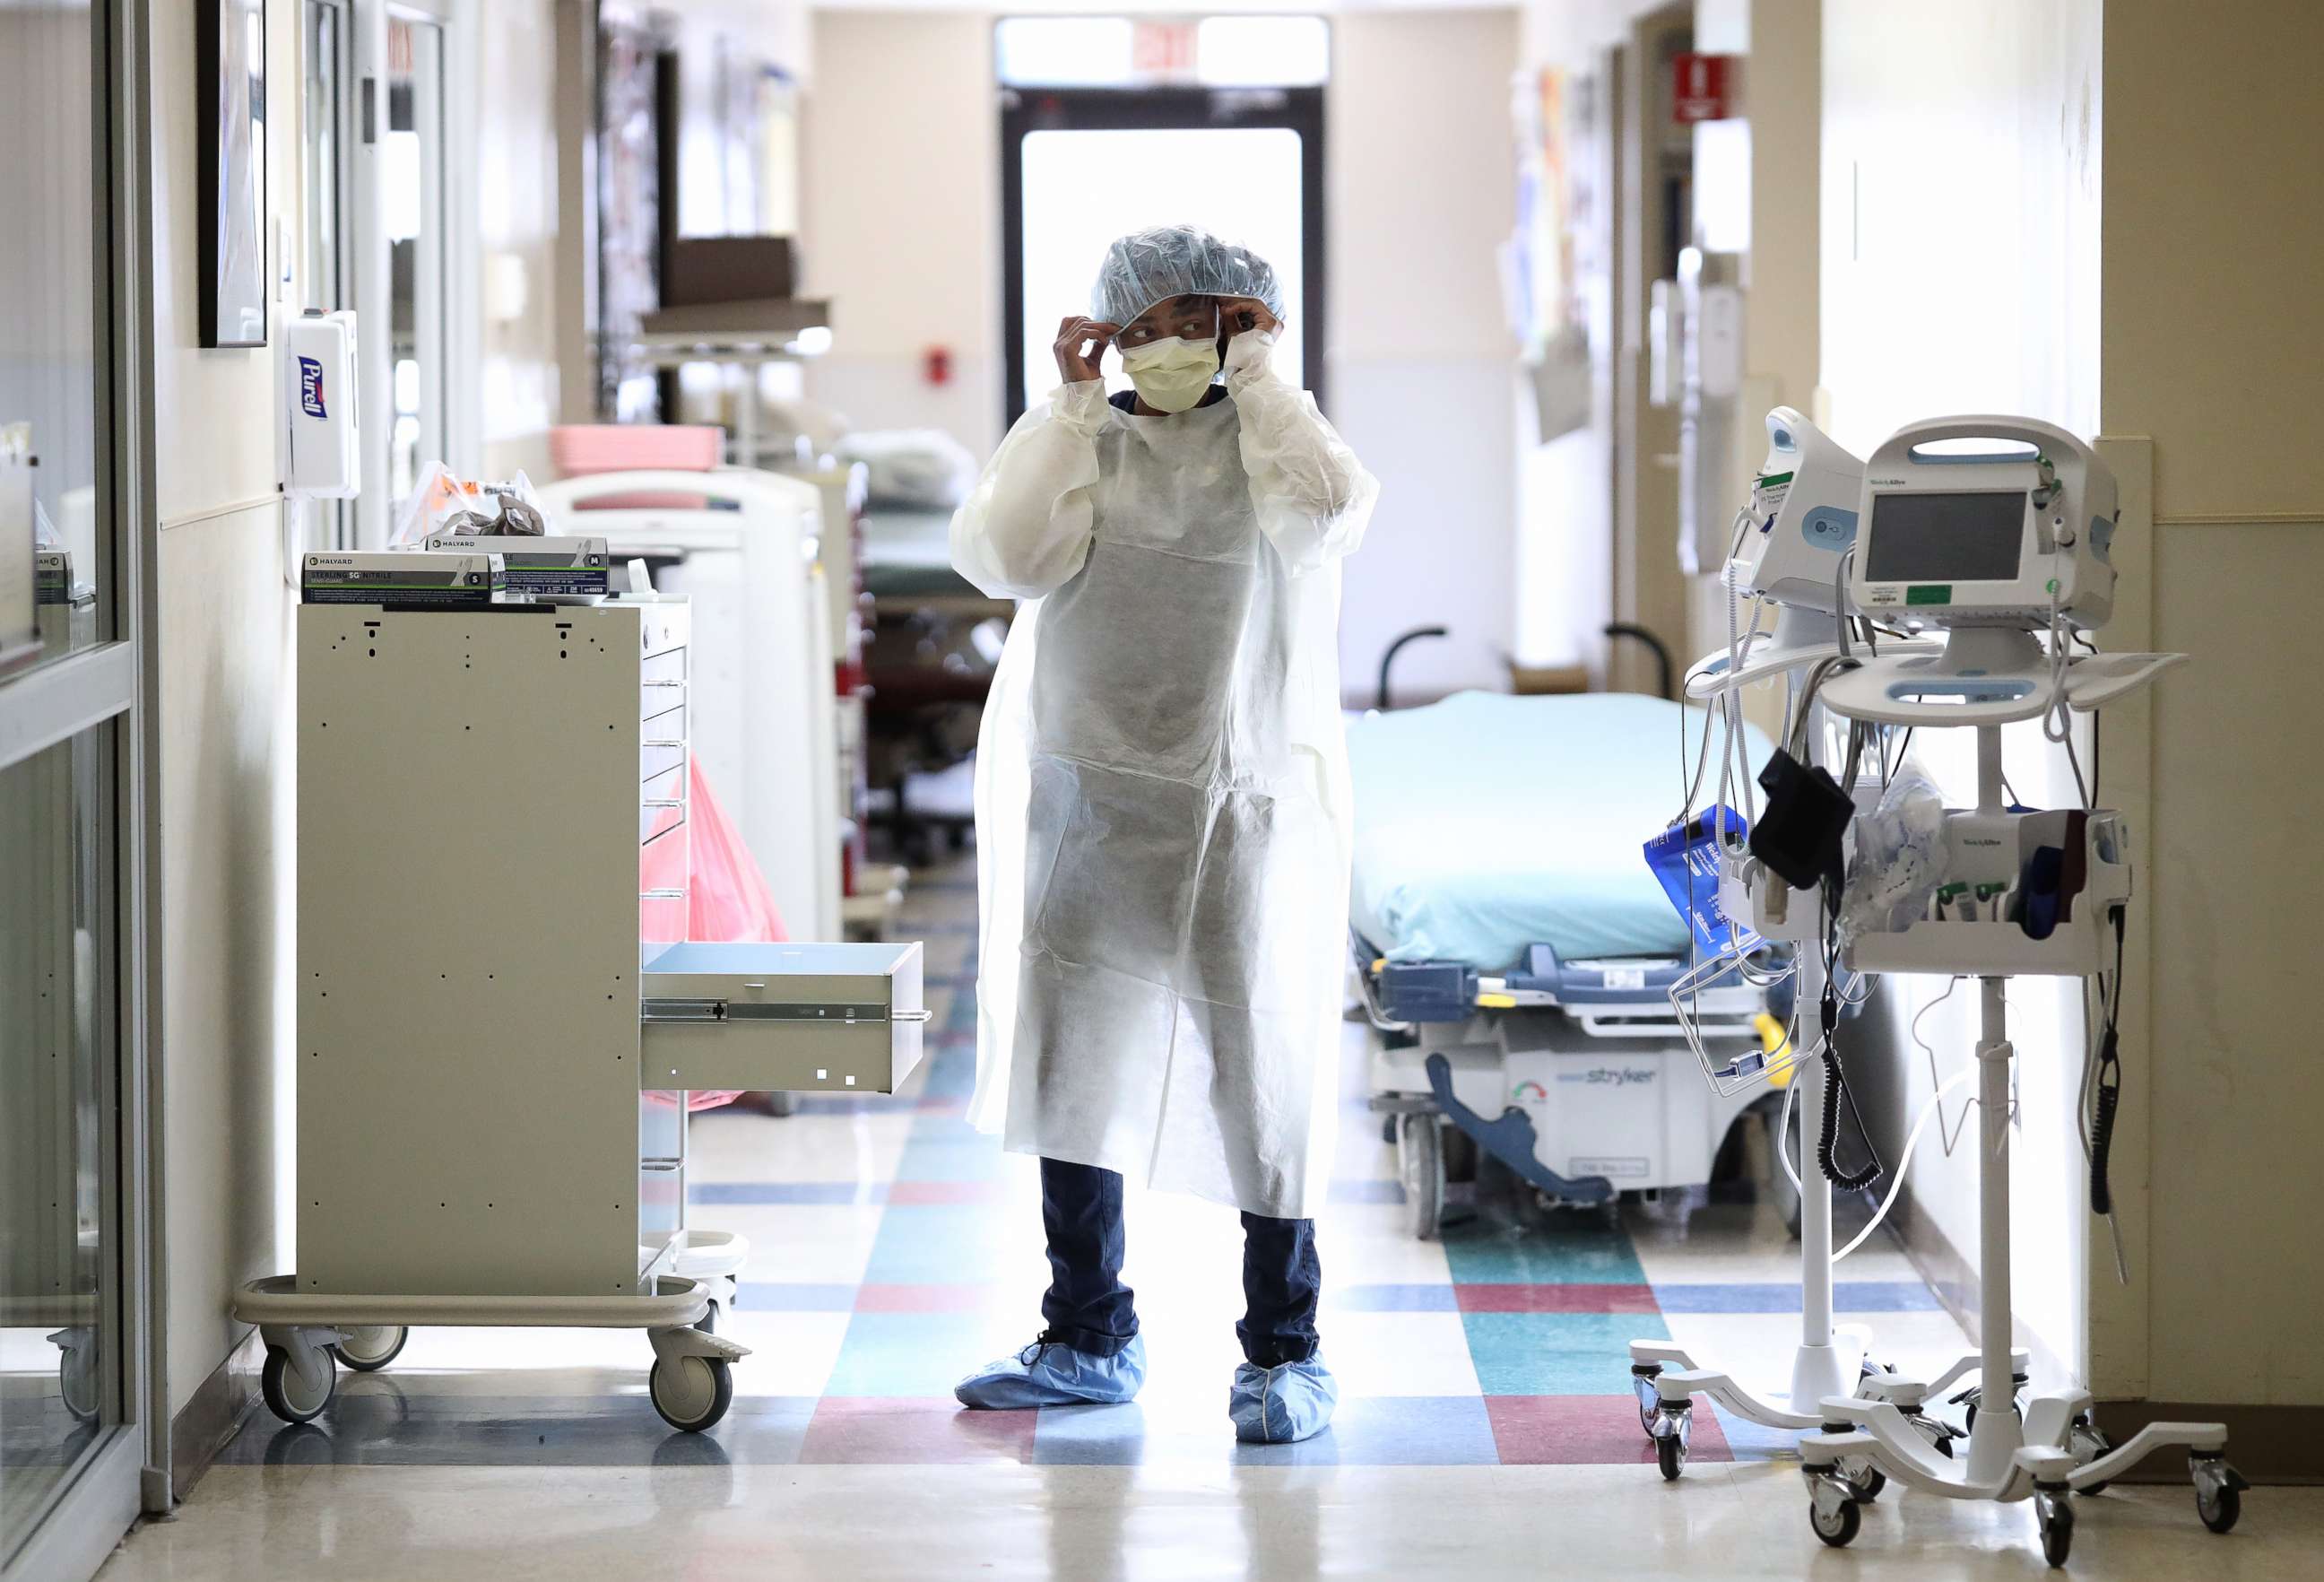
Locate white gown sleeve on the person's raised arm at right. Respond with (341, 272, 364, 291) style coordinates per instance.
(1227, 330, 1381, 576)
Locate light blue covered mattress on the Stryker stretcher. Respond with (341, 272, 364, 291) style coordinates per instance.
(1348, 692, 1771, 971)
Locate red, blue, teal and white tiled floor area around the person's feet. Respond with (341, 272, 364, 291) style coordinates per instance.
(204, 866, 1966, 1468)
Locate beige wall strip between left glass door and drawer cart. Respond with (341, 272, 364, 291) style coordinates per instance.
(153, 0, 299, 1410)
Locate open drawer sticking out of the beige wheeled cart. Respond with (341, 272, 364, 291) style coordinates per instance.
(637, 941, 927, 1094)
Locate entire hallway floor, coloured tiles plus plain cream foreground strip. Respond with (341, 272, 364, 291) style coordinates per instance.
(73, 857, 2324, 1582)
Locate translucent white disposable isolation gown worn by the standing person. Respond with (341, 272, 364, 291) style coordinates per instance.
(953, 332, 1378, 1217)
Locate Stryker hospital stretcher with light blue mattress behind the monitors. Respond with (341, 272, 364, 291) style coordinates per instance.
(1348, 692, 1797, 1239)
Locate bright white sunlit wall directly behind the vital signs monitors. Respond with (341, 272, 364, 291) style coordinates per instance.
(1820, 0, 2112, 1385)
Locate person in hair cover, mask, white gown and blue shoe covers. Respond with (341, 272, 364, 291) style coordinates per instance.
(953, 225, 1378, 1440)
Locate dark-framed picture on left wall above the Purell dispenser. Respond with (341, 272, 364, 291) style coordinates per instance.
(193, 0, 267, 346)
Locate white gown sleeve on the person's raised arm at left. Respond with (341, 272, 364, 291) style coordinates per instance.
(953, 378, 1106, 599)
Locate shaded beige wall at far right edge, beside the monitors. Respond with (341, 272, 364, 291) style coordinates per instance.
(2099, 0, 2324, 1405)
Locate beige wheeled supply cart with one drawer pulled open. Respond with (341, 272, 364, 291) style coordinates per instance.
(235, 589, 925, 1429)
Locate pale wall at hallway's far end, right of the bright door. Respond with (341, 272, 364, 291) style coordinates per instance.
(1324, 12, 1518, 700)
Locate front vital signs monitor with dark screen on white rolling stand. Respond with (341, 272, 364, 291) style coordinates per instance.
(1799, 416, 2250, 1566)
